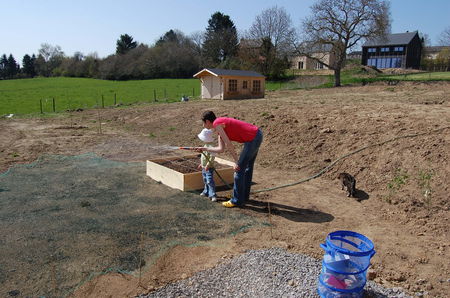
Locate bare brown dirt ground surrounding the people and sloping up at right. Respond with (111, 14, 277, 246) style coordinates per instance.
(0, 83, 450, 297)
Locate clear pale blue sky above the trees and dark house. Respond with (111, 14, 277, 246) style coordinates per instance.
(0, 0, 450, 62)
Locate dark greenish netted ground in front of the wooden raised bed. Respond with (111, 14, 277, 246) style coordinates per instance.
(0, 154, 257, 297)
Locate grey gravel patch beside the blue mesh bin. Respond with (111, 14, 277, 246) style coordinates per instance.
(139, 248, 410, 298)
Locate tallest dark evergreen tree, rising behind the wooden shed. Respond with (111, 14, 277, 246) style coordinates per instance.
(203, 12, 238, 66)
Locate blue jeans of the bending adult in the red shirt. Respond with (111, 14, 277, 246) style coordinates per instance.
(231, 129, 263, 206)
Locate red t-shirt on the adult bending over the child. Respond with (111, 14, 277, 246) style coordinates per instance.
(213, 117, 258, 143)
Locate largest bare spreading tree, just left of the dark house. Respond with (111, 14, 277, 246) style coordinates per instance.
(296, 0, 390, 87)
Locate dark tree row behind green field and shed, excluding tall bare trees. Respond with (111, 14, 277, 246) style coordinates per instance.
(0, 8, 292, 80)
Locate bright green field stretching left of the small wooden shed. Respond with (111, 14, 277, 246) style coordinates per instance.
(0, 77, 200, 116)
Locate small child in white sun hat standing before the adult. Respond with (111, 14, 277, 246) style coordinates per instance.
(198, 128, 217, 202)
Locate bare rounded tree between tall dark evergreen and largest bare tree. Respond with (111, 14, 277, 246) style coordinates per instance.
(247, 6, 295, 56)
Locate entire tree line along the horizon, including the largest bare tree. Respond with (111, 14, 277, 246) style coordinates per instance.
(5, 0, 448, 86)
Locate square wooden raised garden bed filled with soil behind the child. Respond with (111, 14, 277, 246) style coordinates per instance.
(147, 154, 234, 191)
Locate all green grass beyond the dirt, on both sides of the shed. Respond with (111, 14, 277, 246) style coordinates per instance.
(0, 71, 450, 116)
